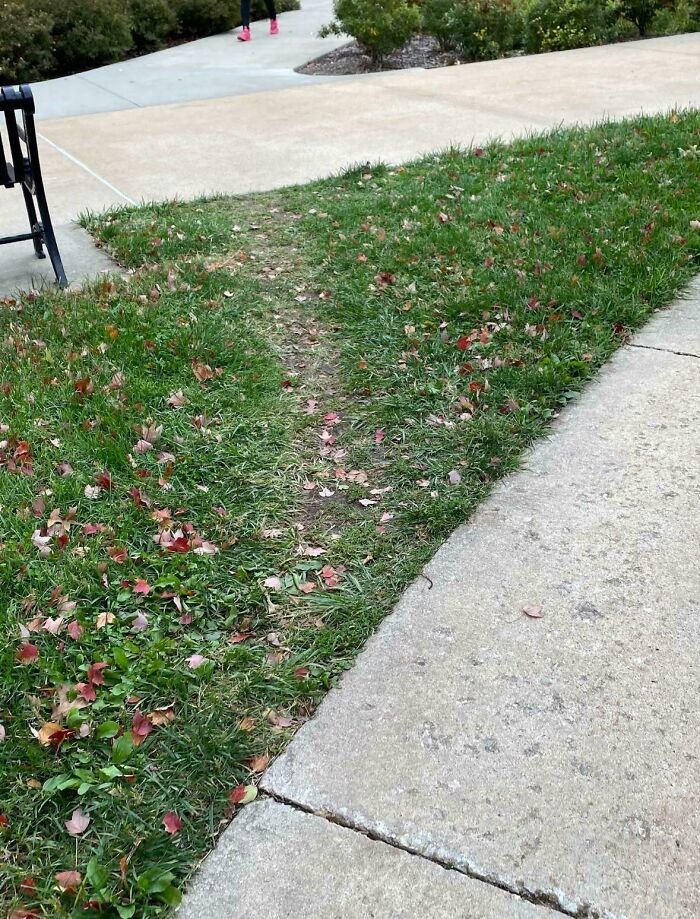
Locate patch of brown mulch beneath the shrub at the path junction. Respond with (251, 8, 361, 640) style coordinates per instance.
(297, 35, 464, 76)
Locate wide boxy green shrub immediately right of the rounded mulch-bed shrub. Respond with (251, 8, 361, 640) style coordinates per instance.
(525, 0, 619, 51)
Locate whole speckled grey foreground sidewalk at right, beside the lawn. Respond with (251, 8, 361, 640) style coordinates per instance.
(178, 284, 700, 919)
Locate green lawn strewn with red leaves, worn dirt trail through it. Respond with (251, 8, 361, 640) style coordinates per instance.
(0, 112, 700, 919)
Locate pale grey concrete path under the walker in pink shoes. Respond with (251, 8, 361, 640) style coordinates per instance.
(34, 0, 348, 120)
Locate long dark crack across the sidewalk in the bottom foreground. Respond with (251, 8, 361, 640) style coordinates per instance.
(262, 790, 627, 919)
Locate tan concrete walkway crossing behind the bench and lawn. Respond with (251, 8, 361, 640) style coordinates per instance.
(0, 33, 700, 289)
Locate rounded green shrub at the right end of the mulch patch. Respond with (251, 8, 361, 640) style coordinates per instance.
(447, 0, 522, 61)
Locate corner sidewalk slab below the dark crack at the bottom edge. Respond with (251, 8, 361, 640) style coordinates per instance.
(176, 800, 553, 919)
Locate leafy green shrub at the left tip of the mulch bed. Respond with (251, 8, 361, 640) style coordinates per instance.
(321, 0, 420, 61)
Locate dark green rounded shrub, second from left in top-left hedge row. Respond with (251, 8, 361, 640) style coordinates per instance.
(45, 0, 133, 73)
